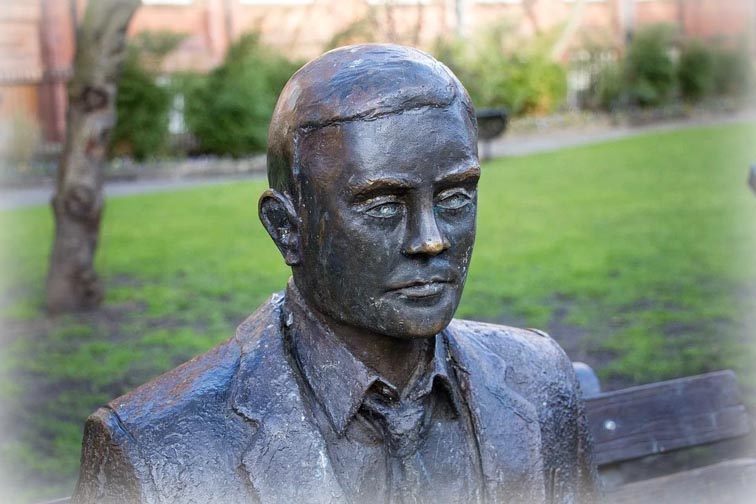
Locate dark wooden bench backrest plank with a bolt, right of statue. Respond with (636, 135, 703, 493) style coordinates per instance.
(585, 371, 750, 465)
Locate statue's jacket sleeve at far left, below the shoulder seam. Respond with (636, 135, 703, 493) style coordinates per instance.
(72, 408, 151, 504)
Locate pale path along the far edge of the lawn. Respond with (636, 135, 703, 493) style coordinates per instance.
(0, 110, 756, 210)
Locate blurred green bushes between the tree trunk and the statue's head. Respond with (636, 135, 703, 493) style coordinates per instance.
(110, 32, 302, 161)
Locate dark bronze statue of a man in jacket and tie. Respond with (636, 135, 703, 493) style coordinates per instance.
(74, 44, 595, 504)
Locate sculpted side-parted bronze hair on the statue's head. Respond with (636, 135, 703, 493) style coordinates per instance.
(267, 44, 477, 197)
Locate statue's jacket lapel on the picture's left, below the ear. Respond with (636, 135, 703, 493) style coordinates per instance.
(231, 295, 346, 503)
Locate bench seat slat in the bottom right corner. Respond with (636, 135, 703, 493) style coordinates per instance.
(606, 459, 756, 504)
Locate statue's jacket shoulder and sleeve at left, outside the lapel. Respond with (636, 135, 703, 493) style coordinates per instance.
(74, 339, 244, 504)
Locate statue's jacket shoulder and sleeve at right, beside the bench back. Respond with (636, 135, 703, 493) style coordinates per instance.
(450, 320, 597, 502)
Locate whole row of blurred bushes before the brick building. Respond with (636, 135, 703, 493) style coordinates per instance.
(110, 23, 753, 161)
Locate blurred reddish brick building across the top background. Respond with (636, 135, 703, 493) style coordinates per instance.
(0, 0, 756, 145)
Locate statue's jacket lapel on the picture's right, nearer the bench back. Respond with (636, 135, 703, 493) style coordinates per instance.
(447, 321, 545, 503)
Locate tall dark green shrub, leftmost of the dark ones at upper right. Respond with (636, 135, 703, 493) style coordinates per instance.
(624, 25, 676, 107)
